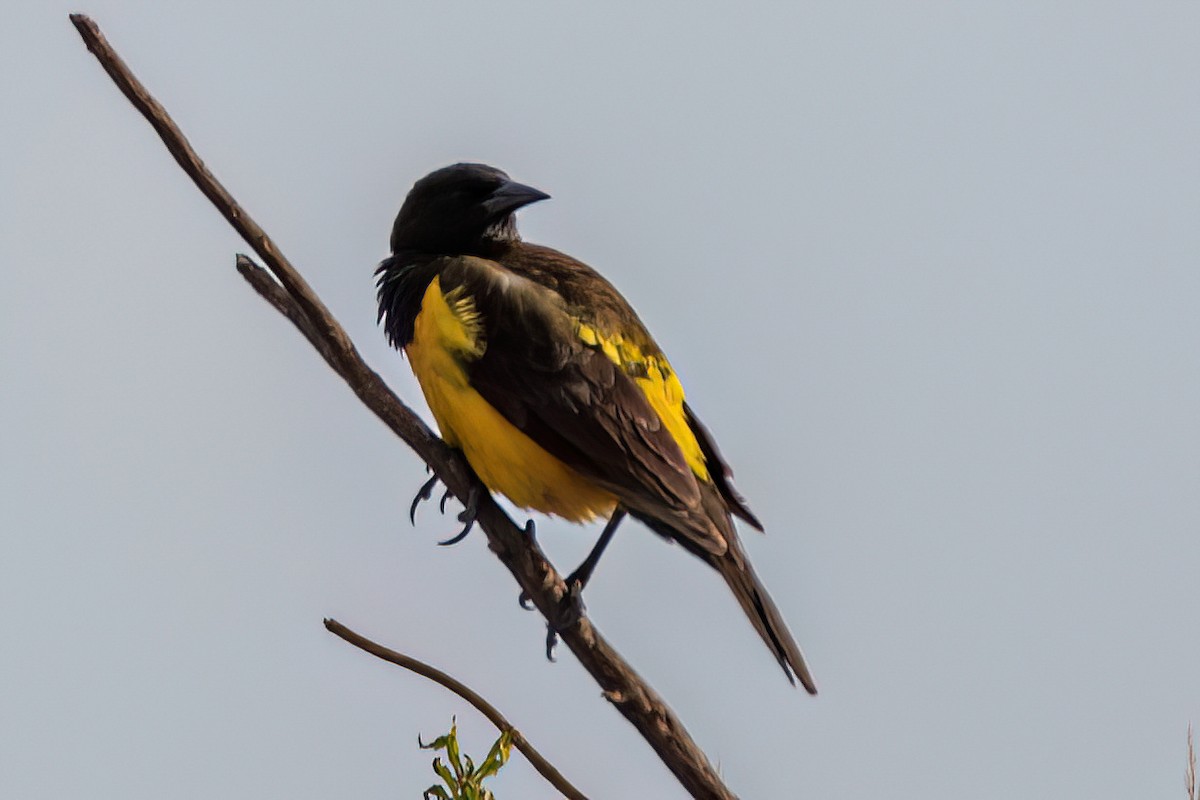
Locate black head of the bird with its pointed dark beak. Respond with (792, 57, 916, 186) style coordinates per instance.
(391, 164, 550, 253)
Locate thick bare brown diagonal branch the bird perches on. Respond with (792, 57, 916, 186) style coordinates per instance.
(71, 14, 734, 800)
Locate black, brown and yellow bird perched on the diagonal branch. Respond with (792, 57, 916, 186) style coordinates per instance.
(376, 163, 816, 694)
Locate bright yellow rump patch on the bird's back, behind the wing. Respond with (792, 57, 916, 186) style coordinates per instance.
(575, 320, 708, 481)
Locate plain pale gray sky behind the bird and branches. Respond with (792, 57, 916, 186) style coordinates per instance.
(0, 0, 1200, 800)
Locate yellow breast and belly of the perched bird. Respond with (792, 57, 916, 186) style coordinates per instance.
(404, 278, 617, 522)
